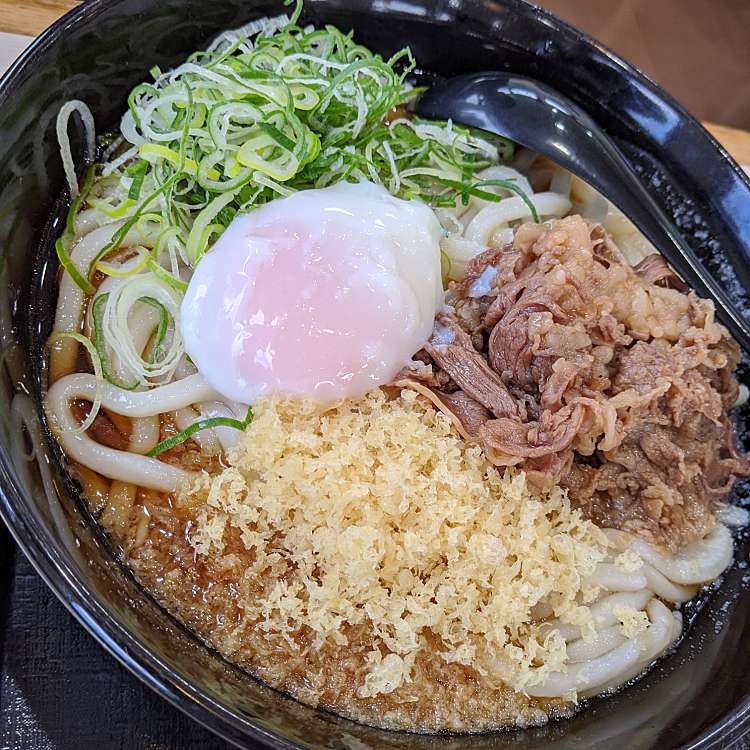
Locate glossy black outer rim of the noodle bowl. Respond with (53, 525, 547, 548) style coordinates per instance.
(0, 0, 750, 750)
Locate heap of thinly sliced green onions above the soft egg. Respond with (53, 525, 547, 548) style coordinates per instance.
(58, 0, 538, 348)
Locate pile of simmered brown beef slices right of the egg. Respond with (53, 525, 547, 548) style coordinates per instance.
(408, 216, 748, 549)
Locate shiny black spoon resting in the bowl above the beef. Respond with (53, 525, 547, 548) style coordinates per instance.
(417, 71, 750, 352)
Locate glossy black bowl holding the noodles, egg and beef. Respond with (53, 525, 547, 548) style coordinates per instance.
(0, 0, 750, 750)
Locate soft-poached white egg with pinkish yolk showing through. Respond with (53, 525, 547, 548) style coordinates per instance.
(181, 182, 443, 403)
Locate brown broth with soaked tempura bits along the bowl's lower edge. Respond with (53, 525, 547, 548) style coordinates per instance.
(73, 446, 572, 732)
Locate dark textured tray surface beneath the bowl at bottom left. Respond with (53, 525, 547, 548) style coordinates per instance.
(0, 522, 235, 750)
